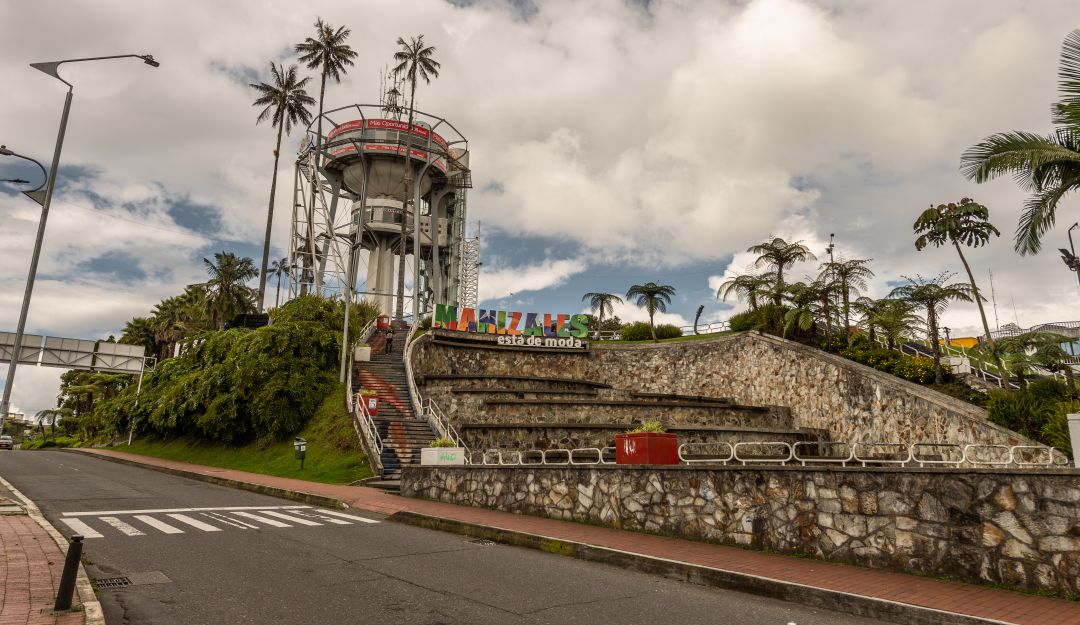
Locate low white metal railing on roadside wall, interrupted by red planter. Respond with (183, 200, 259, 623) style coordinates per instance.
(436, 440, 1071, 468)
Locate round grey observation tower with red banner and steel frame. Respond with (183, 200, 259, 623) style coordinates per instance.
(288, 99, 472, 318)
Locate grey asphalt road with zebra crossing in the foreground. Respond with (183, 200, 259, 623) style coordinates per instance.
(0, 451, 877, 625)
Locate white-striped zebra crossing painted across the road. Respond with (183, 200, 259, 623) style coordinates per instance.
(59, 505, 379, 539)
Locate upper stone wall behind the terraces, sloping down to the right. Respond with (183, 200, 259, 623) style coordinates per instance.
(413, 332, 1030, 446)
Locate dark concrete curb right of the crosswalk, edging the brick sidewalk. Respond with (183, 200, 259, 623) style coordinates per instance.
(388, 512, 1011, 625)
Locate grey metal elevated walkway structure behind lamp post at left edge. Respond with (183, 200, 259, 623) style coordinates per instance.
(0, 332, 156, 373)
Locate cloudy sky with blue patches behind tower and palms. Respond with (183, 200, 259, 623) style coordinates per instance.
(0, 0, 1080, 420)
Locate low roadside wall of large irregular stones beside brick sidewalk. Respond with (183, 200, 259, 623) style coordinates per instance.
(402, 466, 1080, 594)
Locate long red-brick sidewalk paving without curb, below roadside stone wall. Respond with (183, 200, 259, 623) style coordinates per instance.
(79, 449, 1080, 625)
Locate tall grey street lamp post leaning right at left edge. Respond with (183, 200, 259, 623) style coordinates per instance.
(0, 54, 161, 432)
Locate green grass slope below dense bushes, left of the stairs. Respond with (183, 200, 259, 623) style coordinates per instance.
(113, 384, 372, 484)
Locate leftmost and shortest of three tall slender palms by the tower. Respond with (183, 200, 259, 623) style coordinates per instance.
(251, 63, 315, 312)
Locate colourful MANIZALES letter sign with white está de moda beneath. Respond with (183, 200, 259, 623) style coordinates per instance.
(431, 303, 589, 350)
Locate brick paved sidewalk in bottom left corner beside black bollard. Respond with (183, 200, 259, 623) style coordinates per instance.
(0, 503, 85, 625)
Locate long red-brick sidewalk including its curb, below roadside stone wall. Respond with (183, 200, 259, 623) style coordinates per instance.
(76, 449, 1080, 625)
